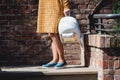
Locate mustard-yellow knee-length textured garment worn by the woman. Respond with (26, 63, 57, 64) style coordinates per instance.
(37, 0, 69, 33)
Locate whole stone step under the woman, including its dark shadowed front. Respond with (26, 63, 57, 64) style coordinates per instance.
(0, 65, 97, 80)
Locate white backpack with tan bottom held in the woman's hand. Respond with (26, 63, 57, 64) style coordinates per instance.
(58, 16, 81, 42)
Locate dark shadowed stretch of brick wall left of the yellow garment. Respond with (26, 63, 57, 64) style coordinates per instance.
(0, 0, 52, 65)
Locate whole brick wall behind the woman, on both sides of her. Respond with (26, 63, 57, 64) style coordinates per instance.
(0, 0, 114, 66)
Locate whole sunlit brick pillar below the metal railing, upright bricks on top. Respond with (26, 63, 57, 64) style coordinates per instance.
(86, 34, 120, 80)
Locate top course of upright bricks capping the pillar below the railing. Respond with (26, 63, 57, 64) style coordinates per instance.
(88, 34, 120, 48)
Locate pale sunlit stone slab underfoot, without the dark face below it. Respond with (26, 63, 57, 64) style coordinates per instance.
(2, 65, 97, 75)
